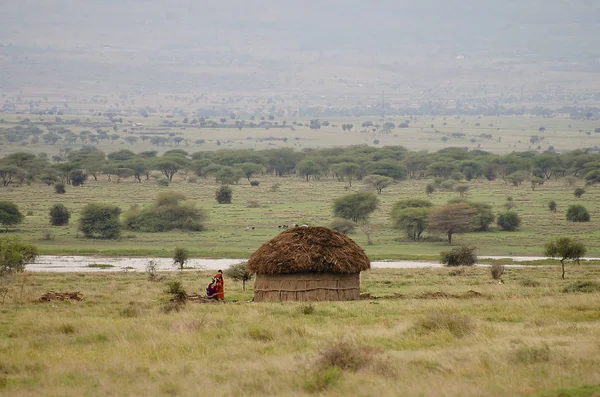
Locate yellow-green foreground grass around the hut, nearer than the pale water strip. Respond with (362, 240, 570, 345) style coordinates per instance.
(0, 265, 600, 397)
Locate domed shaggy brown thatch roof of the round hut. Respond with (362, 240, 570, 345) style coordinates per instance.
(248, 227, 371, 274)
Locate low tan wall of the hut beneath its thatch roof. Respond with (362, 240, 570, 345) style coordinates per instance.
(254, 273, 360, 302)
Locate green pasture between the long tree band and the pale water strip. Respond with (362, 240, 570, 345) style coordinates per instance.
(0, 175, 600, 259)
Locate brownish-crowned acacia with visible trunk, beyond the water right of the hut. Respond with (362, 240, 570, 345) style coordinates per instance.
(428, 203, 477, 244)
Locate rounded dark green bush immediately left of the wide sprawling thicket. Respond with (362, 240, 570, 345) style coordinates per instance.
(79, 203, 121, 239)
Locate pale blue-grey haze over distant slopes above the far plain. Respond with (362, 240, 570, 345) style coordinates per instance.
(0, 0, 600, 106)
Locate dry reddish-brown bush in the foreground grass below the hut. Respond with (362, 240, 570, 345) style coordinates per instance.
(317, 340, 376, 371)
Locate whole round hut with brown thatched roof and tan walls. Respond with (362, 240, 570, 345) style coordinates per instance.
(248, 227, 371, 302)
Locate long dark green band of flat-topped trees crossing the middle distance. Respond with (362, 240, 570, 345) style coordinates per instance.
(0, 146, 600, 192)
